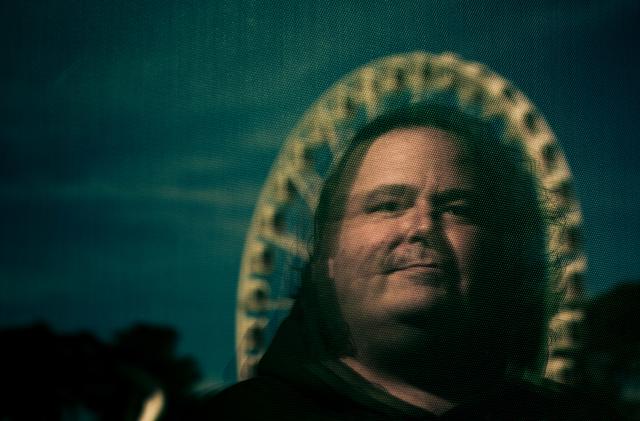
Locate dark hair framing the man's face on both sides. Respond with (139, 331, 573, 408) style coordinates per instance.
(301, 104, 552, 375)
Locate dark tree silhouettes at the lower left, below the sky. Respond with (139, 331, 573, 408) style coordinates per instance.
(0, 323, 200, 421)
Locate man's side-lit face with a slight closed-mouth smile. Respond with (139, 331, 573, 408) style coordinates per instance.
(327, 127, 484, 352)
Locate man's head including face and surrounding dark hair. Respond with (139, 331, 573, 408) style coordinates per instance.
(308, 102, 548, 380)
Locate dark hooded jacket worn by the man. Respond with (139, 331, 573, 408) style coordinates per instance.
(199, 294, 618, 421)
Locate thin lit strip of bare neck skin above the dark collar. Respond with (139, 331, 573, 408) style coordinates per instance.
(341, 357, 457, 415)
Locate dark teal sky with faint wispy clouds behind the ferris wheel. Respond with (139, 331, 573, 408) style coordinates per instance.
(0, 0, 640, 381)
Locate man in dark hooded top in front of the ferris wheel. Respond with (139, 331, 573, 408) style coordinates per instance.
(205, 105, 616, 420)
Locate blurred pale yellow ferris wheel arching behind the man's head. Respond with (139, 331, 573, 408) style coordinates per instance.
(236, 52, 586, 382)
